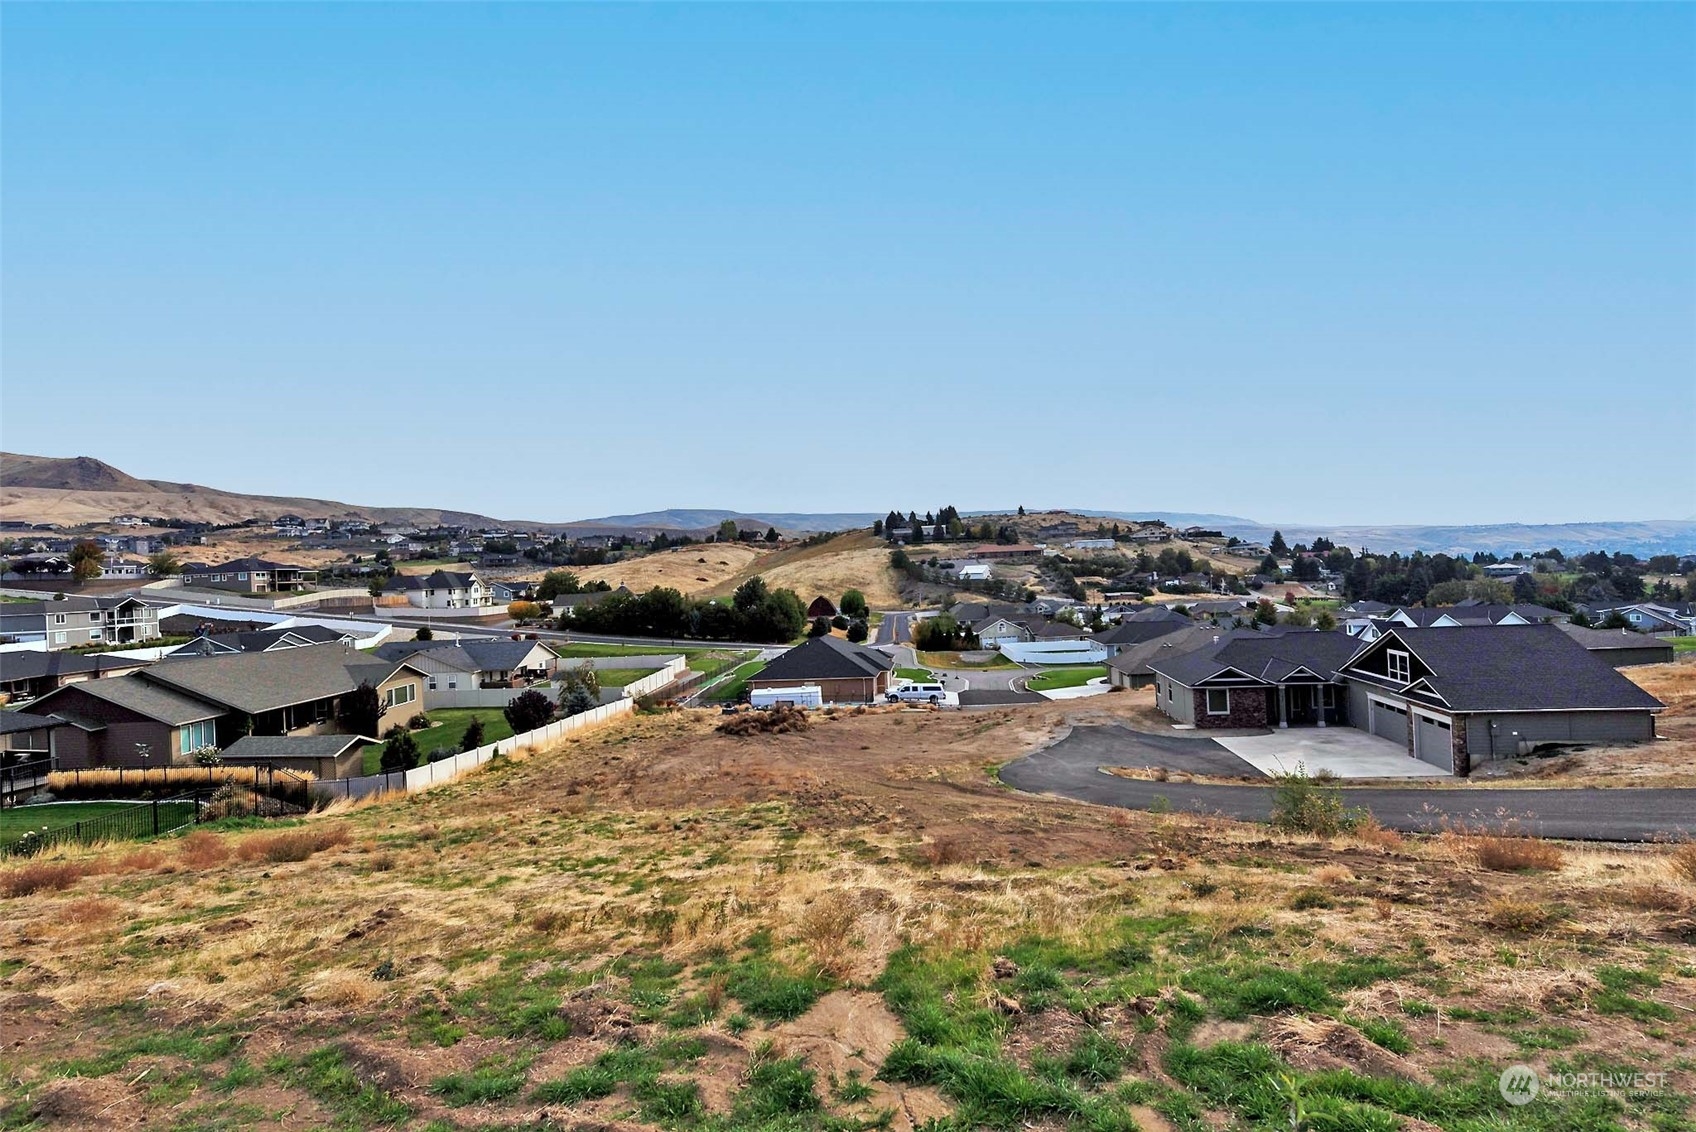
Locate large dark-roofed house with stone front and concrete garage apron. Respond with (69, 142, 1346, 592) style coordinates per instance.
(1150, 625, 1662, 776)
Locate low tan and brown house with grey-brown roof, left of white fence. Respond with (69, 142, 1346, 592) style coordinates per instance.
(34, 643, 424, 767)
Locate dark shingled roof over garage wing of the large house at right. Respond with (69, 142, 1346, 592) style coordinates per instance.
(1342, 625, 1662, 711)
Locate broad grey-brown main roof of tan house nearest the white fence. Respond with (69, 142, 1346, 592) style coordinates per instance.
(139, 645, 417, 715)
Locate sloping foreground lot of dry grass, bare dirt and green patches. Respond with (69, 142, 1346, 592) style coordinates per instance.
(0, 698, 1696, 1132)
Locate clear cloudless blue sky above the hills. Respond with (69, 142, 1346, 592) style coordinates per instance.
(0, 3, 1696, 523)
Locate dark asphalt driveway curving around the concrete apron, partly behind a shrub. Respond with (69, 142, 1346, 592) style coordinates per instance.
(1001, 726, 1696, 842)
